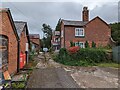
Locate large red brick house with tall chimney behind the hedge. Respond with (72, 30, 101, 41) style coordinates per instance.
(61, 7, 111, 48)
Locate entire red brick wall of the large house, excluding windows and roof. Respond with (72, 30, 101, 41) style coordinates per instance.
(61, 18, 111, 48)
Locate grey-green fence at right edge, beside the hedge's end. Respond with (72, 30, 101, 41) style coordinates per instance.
(112, 46, 120, 63)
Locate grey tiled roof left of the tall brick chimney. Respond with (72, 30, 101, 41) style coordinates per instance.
(62, 20, 87, 26)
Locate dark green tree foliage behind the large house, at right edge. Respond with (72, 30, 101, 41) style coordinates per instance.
(110, 22, 120, 45)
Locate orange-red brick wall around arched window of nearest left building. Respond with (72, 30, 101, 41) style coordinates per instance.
(0, 12, 18, 74)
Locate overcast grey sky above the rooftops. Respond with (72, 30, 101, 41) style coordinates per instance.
(2, 0, 119, 38)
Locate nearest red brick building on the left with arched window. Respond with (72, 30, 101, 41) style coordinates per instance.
(0, 8, 19, 75)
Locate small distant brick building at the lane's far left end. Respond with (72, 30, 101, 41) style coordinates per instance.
(30, 34, 40, 53)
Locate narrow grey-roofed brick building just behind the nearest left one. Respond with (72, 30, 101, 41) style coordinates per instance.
(14, 21, 30, 62)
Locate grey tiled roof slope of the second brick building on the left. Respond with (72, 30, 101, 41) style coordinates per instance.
(14, 21, 26, 37)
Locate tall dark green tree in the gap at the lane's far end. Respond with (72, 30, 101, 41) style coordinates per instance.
(42, 23, 52, 48)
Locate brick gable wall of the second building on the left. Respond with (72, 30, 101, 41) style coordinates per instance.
(20, 28, 28, 53)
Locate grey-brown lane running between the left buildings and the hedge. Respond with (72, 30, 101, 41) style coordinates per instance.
(27, 54, 79, 88)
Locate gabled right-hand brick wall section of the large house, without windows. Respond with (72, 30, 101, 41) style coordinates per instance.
(85, 18, 111, 46)
